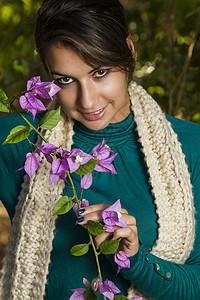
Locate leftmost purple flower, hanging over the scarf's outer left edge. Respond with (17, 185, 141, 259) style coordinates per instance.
(18, 152, 40, 178)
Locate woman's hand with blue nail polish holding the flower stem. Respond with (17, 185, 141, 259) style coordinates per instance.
(78, 203, 139, 256)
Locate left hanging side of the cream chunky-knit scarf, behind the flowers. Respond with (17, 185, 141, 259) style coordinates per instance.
(0, 113, 73, 300)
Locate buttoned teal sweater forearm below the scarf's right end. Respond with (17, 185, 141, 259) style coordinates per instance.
(121, 243, 200, 300)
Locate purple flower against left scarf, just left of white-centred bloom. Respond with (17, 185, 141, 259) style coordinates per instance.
(49, 158, 69, 184)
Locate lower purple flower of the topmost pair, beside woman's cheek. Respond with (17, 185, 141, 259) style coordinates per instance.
(19, 92, 46, 120)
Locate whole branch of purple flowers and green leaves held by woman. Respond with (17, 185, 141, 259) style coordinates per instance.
(0, 76, 142, 300)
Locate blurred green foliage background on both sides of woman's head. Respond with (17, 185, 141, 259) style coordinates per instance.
(0, 0, 200, 123)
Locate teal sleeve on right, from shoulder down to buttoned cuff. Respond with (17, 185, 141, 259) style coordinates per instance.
(106, 118, 200, 300)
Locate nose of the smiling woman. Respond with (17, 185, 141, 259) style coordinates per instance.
(78, 80, 98, 111)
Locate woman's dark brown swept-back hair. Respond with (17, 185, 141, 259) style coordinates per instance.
(35, 0, 135, 81)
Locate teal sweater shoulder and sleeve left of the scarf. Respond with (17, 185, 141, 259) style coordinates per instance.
(0, 113, 43, 219)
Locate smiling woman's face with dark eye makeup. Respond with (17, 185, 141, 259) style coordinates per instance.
(46, 45, 130, 130)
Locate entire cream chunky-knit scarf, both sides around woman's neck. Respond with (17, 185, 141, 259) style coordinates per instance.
(0, 82, 195, 300)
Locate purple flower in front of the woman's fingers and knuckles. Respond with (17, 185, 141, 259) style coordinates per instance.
(102, 199, 127, 232)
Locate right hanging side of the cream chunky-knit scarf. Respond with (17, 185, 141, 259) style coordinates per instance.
(128, 82, 195, 299)
